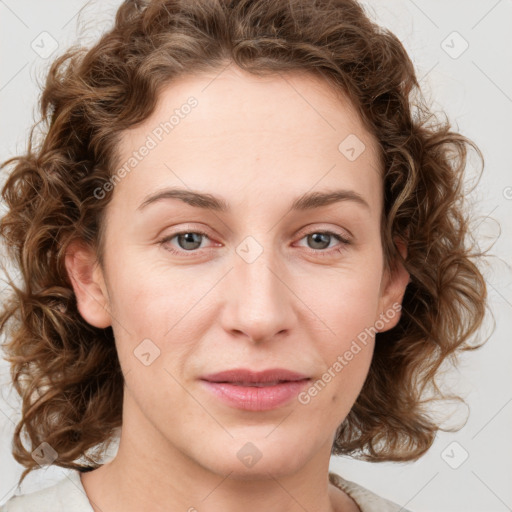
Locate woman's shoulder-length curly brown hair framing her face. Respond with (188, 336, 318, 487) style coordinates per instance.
(0, 0, 487, 488)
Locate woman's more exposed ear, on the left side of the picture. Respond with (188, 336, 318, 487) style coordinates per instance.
(64, 240, 112, 329)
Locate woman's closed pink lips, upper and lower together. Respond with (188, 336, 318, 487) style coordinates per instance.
(201, 368, 310, 411)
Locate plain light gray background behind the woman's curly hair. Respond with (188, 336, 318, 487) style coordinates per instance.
(0, 0, 512, 512)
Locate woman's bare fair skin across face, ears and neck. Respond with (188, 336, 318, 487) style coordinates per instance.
(66, 65, 409, 512)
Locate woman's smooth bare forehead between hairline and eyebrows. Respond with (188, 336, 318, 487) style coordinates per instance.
(114, 66, 381, 214)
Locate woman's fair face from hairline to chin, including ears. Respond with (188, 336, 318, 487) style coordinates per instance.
(66, 66, 407, 478)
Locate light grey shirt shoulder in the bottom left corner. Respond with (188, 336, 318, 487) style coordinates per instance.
(0, 471, 93, 512)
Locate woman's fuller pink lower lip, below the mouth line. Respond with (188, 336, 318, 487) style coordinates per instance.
(202, 379, 309, 411)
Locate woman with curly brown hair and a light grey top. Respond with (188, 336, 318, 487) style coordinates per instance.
(0, 0, 486, 512)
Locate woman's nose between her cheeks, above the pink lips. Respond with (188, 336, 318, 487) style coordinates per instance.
(221, 239, 297, 343)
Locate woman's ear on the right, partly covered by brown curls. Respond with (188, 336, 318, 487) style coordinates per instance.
(375, 238, 411, 332)
